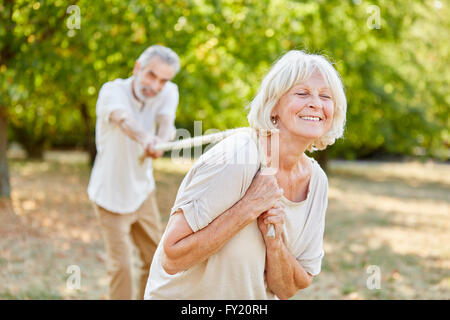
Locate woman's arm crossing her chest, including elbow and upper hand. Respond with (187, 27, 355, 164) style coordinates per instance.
(162, 173, 283, 274)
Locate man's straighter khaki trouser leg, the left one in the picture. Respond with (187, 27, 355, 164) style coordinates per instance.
(96, 206, 134, 300)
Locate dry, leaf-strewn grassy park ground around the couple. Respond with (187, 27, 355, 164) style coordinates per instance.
(0, 152, 450, 299)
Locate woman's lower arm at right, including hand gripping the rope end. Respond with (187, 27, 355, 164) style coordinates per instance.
(258, 207, 313, 300)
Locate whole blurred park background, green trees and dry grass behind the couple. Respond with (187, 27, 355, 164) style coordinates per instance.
(0, 0, 450, 299)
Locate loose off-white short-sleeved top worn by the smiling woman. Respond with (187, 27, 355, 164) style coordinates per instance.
(144, 129, 328, 300)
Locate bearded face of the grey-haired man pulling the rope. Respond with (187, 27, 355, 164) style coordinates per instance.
(133, 56, 175, 100)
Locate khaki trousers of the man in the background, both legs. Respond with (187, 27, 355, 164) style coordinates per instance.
(94, 192, 162, 300)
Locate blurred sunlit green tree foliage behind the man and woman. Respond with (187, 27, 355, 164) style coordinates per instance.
(0, 0, 450, 159)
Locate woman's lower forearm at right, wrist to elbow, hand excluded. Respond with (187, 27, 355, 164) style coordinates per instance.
(266, 239, 312, 299)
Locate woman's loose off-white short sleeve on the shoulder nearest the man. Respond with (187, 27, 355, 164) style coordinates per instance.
(171, 133, 259, 232)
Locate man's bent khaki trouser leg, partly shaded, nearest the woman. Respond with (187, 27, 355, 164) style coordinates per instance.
(131, 191, 163, 299)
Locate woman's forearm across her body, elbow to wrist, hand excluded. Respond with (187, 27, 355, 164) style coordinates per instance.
(162, 201, 257, 274)
